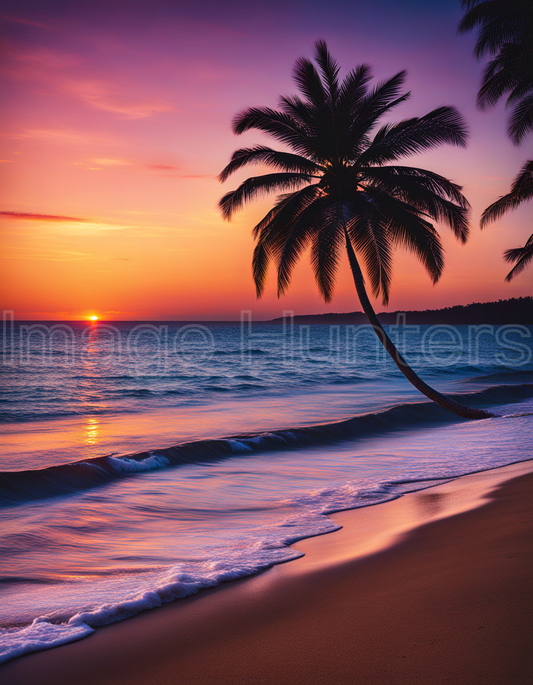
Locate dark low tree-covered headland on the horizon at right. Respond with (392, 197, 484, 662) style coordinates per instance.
(272, 297, 533, 326)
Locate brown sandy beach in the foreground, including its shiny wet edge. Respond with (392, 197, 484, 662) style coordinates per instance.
(0, 462, 533, 685)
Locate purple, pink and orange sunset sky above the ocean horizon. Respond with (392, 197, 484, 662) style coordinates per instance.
(0, 0, 532, 320)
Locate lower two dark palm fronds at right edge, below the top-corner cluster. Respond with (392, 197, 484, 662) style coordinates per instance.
(481, 161, 533, 281)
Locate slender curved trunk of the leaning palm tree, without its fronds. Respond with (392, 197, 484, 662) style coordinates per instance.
(344, 228, 494, 419)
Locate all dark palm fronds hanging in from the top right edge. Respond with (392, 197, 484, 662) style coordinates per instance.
(458, 0, 533, 281)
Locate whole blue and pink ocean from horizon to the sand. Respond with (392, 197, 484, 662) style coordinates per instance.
(0, 320, 533, 663)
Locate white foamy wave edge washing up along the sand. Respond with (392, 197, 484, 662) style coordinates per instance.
(0, 474, 456, 664)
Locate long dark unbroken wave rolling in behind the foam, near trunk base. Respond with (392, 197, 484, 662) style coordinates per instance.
(0, 384, 533, 506)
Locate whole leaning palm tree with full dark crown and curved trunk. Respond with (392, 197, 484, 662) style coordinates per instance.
(219, 41, 492, 419)
